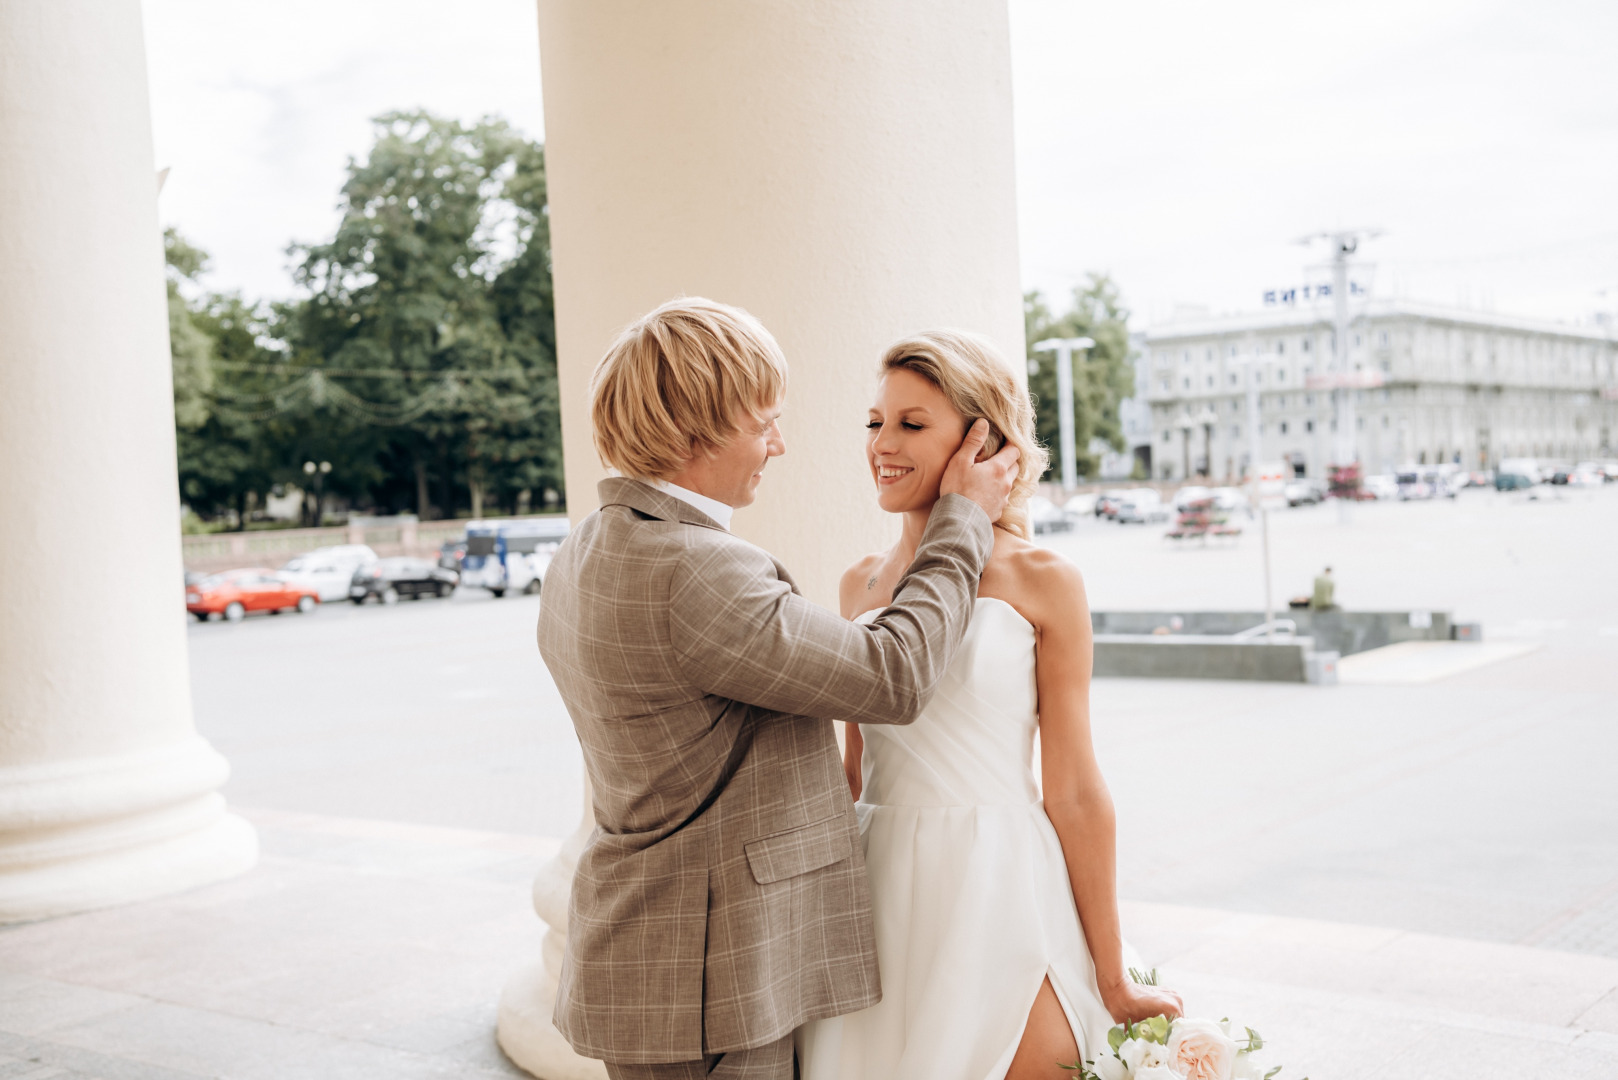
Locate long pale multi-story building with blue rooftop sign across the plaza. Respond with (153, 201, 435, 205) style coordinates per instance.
(1137, 300, 1618, 479)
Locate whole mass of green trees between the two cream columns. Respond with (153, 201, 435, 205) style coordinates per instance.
(168, 112, 563, 517)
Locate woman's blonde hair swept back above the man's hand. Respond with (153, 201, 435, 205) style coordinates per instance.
(882, 330, 1050, 539)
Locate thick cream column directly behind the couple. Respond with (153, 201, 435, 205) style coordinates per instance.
(500, 0, 1026, 1080)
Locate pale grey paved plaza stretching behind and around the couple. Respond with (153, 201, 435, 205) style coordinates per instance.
(0, 487, 1618, 1080)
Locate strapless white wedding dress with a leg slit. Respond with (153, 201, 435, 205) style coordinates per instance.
(798, 597, 1113, 1080)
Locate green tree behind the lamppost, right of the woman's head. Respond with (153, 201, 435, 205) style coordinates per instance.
(1023, 274, 1134, 476)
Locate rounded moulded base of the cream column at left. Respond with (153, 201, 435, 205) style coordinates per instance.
(0, 738, 259, 923)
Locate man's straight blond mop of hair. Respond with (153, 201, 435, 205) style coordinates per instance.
(591, 296, 786, 479)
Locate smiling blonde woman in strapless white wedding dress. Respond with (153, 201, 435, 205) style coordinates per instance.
(798, 330, 1181, 1080)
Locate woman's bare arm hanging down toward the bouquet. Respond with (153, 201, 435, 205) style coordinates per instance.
(1014, 549, 1181, 1020)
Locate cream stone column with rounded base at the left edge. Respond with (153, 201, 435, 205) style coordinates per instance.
(0, 0, 257, 921)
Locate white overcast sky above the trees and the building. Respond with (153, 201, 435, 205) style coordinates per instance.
(144, 0, 1618, 325)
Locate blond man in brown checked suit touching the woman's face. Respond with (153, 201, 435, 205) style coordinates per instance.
(539, 300, 1016, 1080)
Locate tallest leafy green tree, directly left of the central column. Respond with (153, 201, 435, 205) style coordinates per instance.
(288, 112, 561, 517)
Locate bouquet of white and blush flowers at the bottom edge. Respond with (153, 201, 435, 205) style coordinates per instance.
(1063, 968, 1309, 1080)
